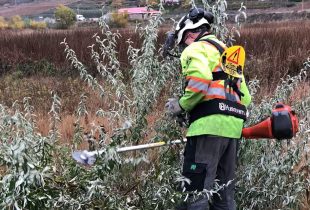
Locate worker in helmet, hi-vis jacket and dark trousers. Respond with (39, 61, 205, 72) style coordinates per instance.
(164, 8, 251, 210)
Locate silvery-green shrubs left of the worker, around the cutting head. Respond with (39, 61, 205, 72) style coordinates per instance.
(0, 6, 180, 209)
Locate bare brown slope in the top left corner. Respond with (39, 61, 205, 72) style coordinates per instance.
(0, 0, 78, 17)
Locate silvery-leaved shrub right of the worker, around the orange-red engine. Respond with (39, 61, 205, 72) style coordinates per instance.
(237, 58, 310, 209)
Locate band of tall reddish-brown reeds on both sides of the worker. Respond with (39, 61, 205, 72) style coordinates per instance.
(0, 20, 310, 88)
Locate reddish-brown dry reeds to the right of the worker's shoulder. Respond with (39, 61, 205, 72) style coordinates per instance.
(238, 21, 310, 96)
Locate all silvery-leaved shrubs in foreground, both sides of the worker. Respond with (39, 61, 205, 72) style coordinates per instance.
(0, 1, 310, 210)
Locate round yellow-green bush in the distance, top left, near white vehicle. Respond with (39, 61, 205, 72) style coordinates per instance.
(55, 5, 76, 29)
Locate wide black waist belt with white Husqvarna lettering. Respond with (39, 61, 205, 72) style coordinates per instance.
(189, 98, 246, 123)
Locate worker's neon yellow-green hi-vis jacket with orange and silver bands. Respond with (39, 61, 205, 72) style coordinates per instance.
(179, 35, 251, 138)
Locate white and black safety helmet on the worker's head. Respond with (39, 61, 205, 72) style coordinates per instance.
(175, 8, 214, 44)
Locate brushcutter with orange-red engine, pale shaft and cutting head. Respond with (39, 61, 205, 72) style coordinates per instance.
(72, 103, 298, 165)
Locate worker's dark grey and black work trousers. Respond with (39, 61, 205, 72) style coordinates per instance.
(183, 135, 237, 210)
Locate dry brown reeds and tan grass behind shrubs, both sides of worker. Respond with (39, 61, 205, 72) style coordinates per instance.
(0, 21, 310, 142)
